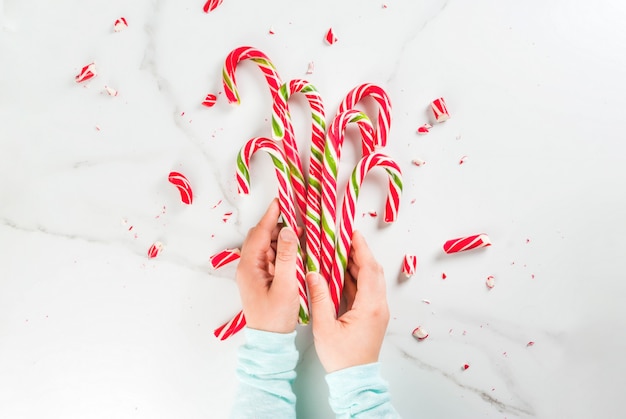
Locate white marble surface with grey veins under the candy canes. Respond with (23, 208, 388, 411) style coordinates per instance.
(0, 0, 626, 418)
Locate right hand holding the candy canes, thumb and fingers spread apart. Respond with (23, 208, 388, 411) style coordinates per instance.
(306, 231, 389, 373)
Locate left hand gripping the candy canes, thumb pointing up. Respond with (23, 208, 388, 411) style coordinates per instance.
(236, 199, 300, 333)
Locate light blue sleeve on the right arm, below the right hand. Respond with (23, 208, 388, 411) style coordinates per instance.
(326, 363, 400, 419)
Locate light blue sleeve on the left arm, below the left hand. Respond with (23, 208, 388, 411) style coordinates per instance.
(231, 328, 298, 419)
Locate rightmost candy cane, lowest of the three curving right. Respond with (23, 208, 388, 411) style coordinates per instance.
(330, 153, 402, 310)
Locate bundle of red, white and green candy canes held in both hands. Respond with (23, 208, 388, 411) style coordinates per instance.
(211, 46, 402, 340)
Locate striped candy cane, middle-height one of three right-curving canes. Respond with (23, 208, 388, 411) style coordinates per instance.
(320, 109, 374, 281)
